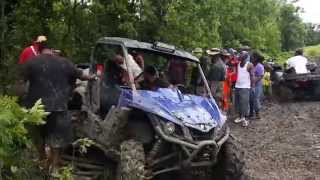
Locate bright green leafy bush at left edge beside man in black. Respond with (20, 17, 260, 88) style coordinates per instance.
(0, 96, 47, 167)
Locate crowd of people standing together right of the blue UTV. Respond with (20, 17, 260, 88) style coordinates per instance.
(193, 48, 265, 127)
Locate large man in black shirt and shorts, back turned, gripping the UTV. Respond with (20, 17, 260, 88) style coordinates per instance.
(21, 47, 95, 173)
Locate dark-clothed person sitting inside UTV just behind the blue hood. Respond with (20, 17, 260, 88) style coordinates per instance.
(138, 66, 170, 91)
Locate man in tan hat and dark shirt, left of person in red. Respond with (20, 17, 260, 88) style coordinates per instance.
(207, 48, 226, 107)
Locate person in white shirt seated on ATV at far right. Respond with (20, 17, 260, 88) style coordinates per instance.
(287, 49, 308, 74)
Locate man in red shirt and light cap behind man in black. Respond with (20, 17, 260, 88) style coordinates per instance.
(19, 36, 47, 64)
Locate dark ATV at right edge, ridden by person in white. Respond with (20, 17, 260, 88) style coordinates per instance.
(270, 63, 320, 102)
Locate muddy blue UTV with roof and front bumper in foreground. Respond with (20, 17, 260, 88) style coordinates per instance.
(63, 37, 244, 180)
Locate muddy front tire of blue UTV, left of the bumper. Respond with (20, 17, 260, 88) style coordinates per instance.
(117, 140, 145, 180)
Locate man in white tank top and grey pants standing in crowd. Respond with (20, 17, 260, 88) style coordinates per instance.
(234, 51, 253, 127)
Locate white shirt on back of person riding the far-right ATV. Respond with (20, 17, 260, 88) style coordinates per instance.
(287, 55, 308, 74)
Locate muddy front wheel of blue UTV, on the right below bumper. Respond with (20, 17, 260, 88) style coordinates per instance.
(213, 137, 246, 180)
